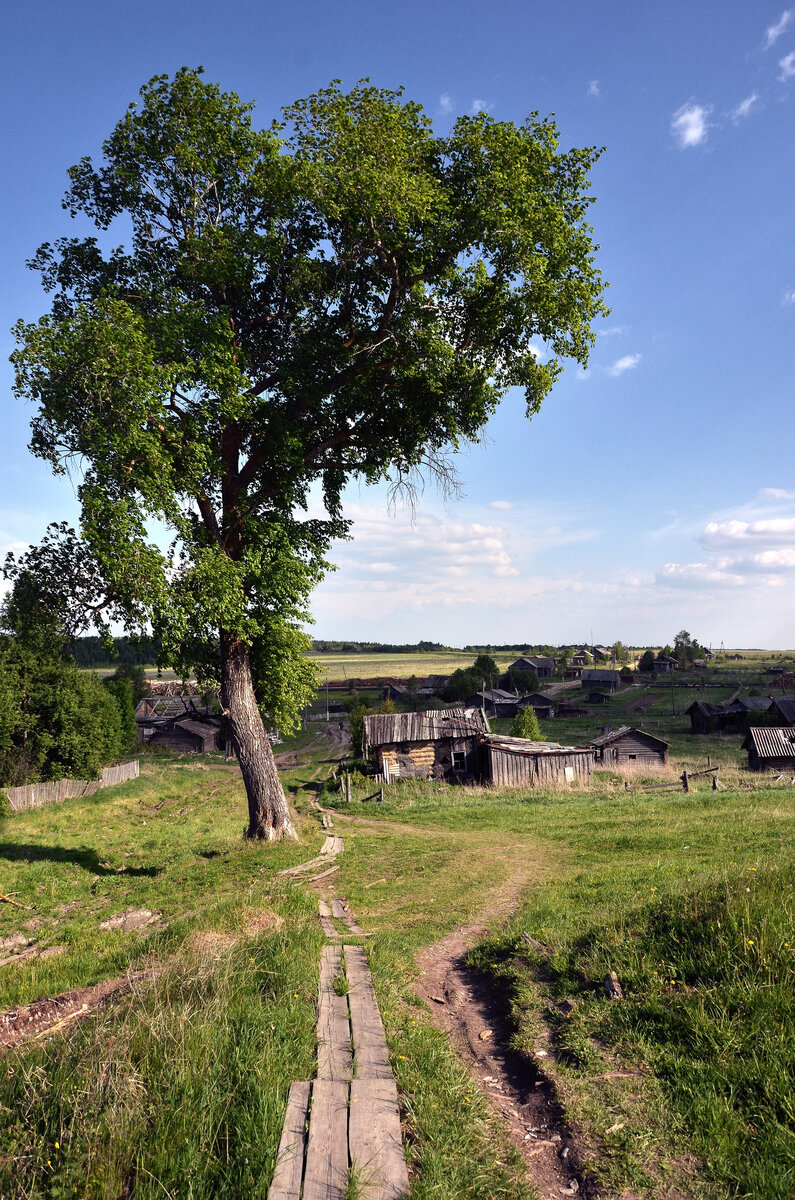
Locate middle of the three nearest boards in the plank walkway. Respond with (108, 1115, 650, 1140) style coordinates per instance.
(303, 1079, 348, 1200)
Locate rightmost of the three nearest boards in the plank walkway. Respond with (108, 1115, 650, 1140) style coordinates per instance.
(348, 1079, 408, 1200)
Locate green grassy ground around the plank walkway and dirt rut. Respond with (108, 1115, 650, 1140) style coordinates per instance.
(0, 718, 795, 1200)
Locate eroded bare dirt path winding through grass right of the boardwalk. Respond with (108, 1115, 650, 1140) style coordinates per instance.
(416, 870, 594, 1200)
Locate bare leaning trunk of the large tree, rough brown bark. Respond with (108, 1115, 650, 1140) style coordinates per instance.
(221, 631, 298, 841)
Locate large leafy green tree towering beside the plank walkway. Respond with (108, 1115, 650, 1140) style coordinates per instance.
(14, 70, 605, 839)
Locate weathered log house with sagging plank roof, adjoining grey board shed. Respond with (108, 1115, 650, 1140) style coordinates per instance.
(363, 708, 489, 781)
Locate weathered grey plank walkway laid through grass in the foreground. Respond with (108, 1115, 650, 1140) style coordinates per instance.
(268, 883, 408, 1200)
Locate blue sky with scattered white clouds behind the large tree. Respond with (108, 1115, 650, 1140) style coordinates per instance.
(0, 0, 795, 648)
